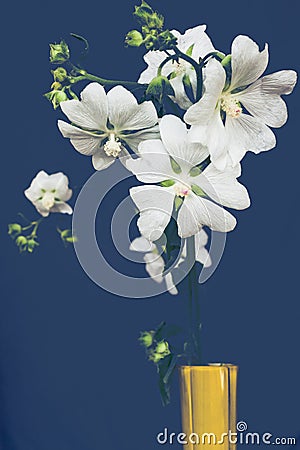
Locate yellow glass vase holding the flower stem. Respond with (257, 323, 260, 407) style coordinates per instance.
(179, 364, 238, 450)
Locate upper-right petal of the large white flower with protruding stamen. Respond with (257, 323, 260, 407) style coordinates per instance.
(107, 86, 158, 133)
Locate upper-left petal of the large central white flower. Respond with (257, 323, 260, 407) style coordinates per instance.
(126, 139, 175, 183)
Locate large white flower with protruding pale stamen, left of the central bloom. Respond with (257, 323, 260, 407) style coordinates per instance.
(58, 83, 158, 170)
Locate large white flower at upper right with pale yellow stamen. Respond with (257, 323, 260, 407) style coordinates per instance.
(184, 36, 297, 170)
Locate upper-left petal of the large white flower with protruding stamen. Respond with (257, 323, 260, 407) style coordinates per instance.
(60, 83, 108, 131)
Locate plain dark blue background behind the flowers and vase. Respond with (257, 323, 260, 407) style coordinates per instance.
(0, 0, 300, 450)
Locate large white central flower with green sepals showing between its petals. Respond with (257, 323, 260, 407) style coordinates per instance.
(126, 115, 250, 241)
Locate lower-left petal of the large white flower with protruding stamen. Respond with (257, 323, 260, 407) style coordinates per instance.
(57, 120, 104, 156)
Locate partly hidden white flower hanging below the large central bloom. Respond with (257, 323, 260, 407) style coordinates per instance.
(130, 229, 211, 295)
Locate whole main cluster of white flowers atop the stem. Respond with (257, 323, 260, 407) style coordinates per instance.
(54, 21, 296, 293)
